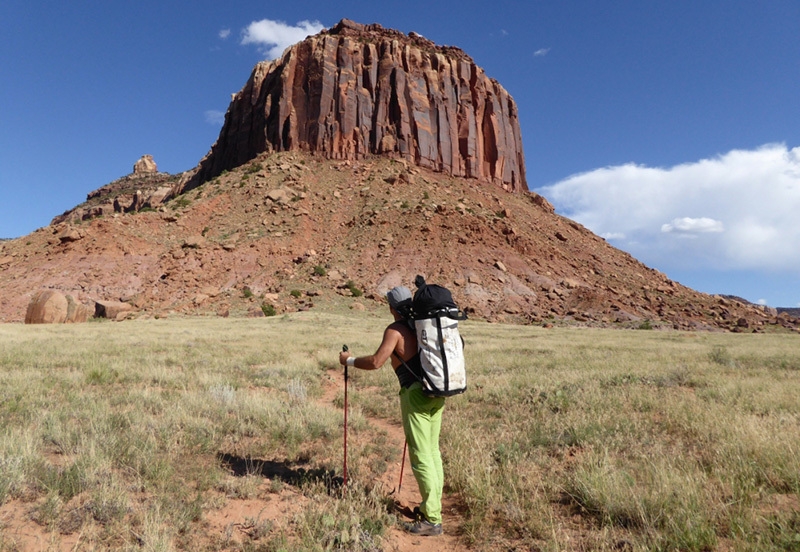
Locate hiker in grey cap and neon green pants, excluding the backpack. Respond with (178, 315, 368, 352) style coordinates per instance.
(339, 286, 444, 536)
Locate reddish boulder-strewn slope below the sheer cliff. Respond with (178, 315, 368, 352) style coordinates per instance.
(0, 152, 797, 331)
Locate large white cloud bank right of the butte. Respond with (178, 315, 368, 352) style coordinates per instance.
(537, 144, 800, 272)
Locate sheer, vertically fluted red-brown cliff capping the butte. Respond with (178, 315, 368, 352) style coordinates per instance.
(186, 20, 527, 192)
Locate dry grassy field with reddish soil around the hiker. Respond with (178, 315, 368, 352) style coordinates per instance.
(0, 312, 800, 551)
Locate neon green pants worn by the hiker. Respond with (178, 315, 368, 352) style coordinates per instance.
(400, 383, 444, 523)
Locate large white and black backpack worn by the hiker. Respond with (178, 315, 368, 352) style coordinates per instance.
(403, 276, 467, 397)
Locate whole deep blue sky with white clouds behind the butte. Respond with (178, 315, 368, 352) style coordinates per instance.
(0, 0, 800, 306)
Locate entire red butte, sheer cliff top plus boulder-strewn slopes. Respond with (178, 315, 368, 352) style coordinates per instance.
(0, 21, 798, 331)
